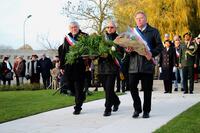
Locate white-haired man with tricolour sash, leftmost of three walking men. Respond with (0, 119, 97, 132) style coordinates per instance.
(58, 21, 87, 115)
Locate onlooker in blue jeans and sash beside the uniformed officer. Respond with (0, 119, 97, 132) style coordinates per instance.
(174, 35, 184, 91)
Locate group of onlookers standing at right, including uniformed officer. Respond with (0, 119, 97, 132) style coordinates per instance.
(158, 32, 200, 94)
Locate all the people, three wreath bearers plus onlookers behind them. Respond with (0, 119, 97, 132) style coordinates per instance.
(0, 11, 200, 118)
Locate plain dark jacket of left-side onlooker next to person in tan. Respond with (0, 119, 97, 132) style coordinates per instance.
(39, 57, 53, 78)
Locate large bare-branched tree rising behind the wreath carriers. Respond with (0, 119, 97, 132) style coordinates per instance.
(62, 0, 114, 34)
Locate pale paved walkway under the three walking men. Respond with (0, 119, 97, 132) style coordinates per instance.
(0, 81, 200, 133)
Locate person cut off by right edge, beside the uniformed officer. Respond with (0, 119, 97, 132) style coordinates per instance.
(194, 34, 200, 83)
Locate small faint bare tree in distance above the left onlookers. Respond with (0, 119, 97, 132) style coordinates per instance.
(37, 34, 60, 51)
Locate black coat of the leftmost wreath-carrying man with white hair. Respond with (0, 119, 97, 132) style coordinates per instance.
(58, 30, 88, 80)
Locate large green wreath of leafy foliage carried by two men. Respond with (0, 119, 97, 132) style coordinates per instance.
(65, 34, 119, 64)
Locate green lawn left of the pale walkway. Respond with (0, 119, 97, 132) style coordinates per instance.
(0, 90, 104, 123)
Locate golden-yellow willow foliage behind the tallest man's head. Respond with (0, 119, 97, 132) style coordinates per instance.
(114, 0, 200, 39)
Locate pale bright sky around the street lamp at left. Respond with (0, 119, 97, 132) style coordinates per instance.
(0, 0, 81, 49)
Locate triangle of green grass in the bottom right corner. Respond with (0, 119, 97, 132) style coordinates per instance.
(154, 103, 200, 133)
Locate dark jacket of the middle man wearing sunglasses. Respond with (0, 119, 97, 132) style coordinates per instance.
(98, 33, 122, 74)
